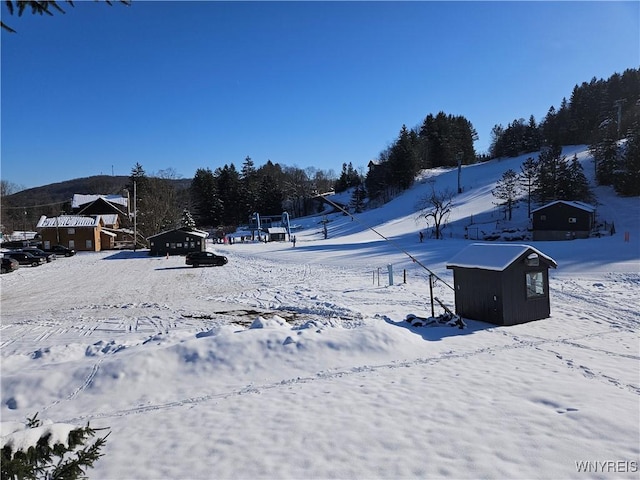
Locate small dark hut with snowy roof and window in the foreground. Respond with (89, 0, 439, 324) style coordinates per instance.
(447, 243, 558, 325)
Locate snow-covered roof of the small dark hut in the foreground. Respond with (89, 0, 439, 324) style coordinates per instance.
(447, 243, 558, 272)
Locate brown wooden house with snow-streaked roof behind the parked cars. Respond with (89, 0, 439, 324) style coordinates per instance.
(36, 215, 106, 252)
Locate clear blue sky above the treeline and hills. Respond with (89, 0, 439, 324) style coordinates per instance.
(1, 0, 640, 189)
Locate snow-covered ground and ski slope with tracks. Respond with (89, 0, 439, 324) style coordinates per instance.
(0, 147, 640, 479)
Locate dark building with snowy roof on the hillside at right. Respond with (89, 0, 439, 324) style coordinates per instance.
(531, 200, 596, 241)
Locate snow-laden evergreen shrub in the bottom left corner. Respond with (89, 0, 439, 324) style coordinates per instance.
(0, 413, 109, 480)
